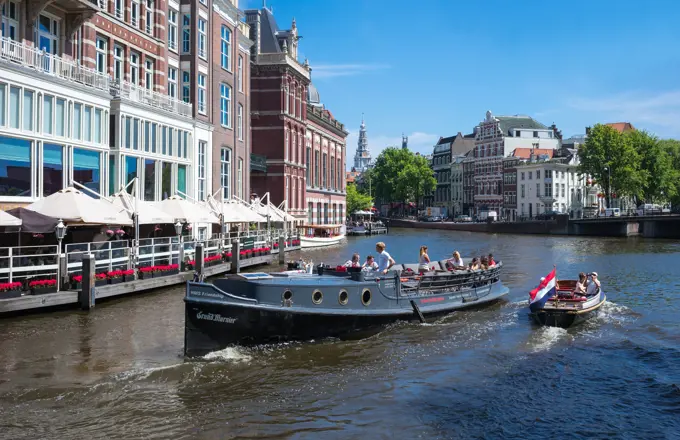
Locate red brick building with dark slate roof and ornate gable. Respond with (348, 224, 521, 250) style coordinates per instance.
(246, 7, 347, 227)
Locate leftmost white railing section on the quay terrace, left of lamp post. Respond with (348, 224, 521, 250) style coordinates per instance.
(0, 245, 59, 283)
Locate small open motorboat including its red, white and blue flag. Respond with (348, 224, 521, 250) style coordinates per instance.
(529, 269, 607, 328)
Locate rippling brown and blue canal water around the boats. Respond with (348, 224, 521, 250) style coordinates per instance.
(0, 229, 680, 439)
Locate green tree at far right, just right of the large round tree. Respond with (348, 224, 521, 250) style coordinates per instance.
(624, 130, 678, 203)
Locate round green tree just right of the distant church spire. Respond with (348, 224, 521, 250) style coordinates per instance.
(362, 147, 437, 202)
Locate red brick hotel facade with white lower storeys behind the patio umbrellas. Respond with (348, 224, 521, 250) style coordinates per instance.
(0, 0, 249, 213)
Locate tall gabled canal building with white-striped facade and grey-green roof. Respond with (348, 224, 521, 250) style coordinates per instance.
(473, 111, 559, 214)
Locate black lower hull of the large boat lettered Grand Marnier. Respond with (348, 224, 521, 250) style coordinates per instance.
(184, 296, 502, 356)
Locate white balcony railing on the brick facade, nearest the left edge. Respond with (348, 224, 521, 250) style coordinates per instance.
(0, 37, 109, 92)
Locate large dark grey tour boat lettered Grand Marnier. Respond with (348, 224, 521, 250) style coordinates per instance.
(184, 262, 508, 356)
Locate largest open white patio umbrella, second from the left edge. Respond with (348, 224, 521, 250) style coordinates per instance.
(26, 187, 132, 225)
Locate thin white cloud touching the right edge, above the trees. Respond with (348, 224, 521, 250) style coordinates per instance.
(568, 90, 680, 135)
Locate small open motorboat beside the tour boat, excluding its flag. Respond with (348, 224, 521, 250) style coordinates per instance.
(530, 280, 607, 328)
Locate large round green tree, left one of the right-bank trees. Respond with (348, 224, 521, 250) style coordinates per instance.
(578, 124, 647, 200)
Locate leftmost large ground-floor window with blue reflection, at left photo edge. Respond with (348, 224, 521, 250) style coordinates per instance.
(0, 136, 32, 197)
